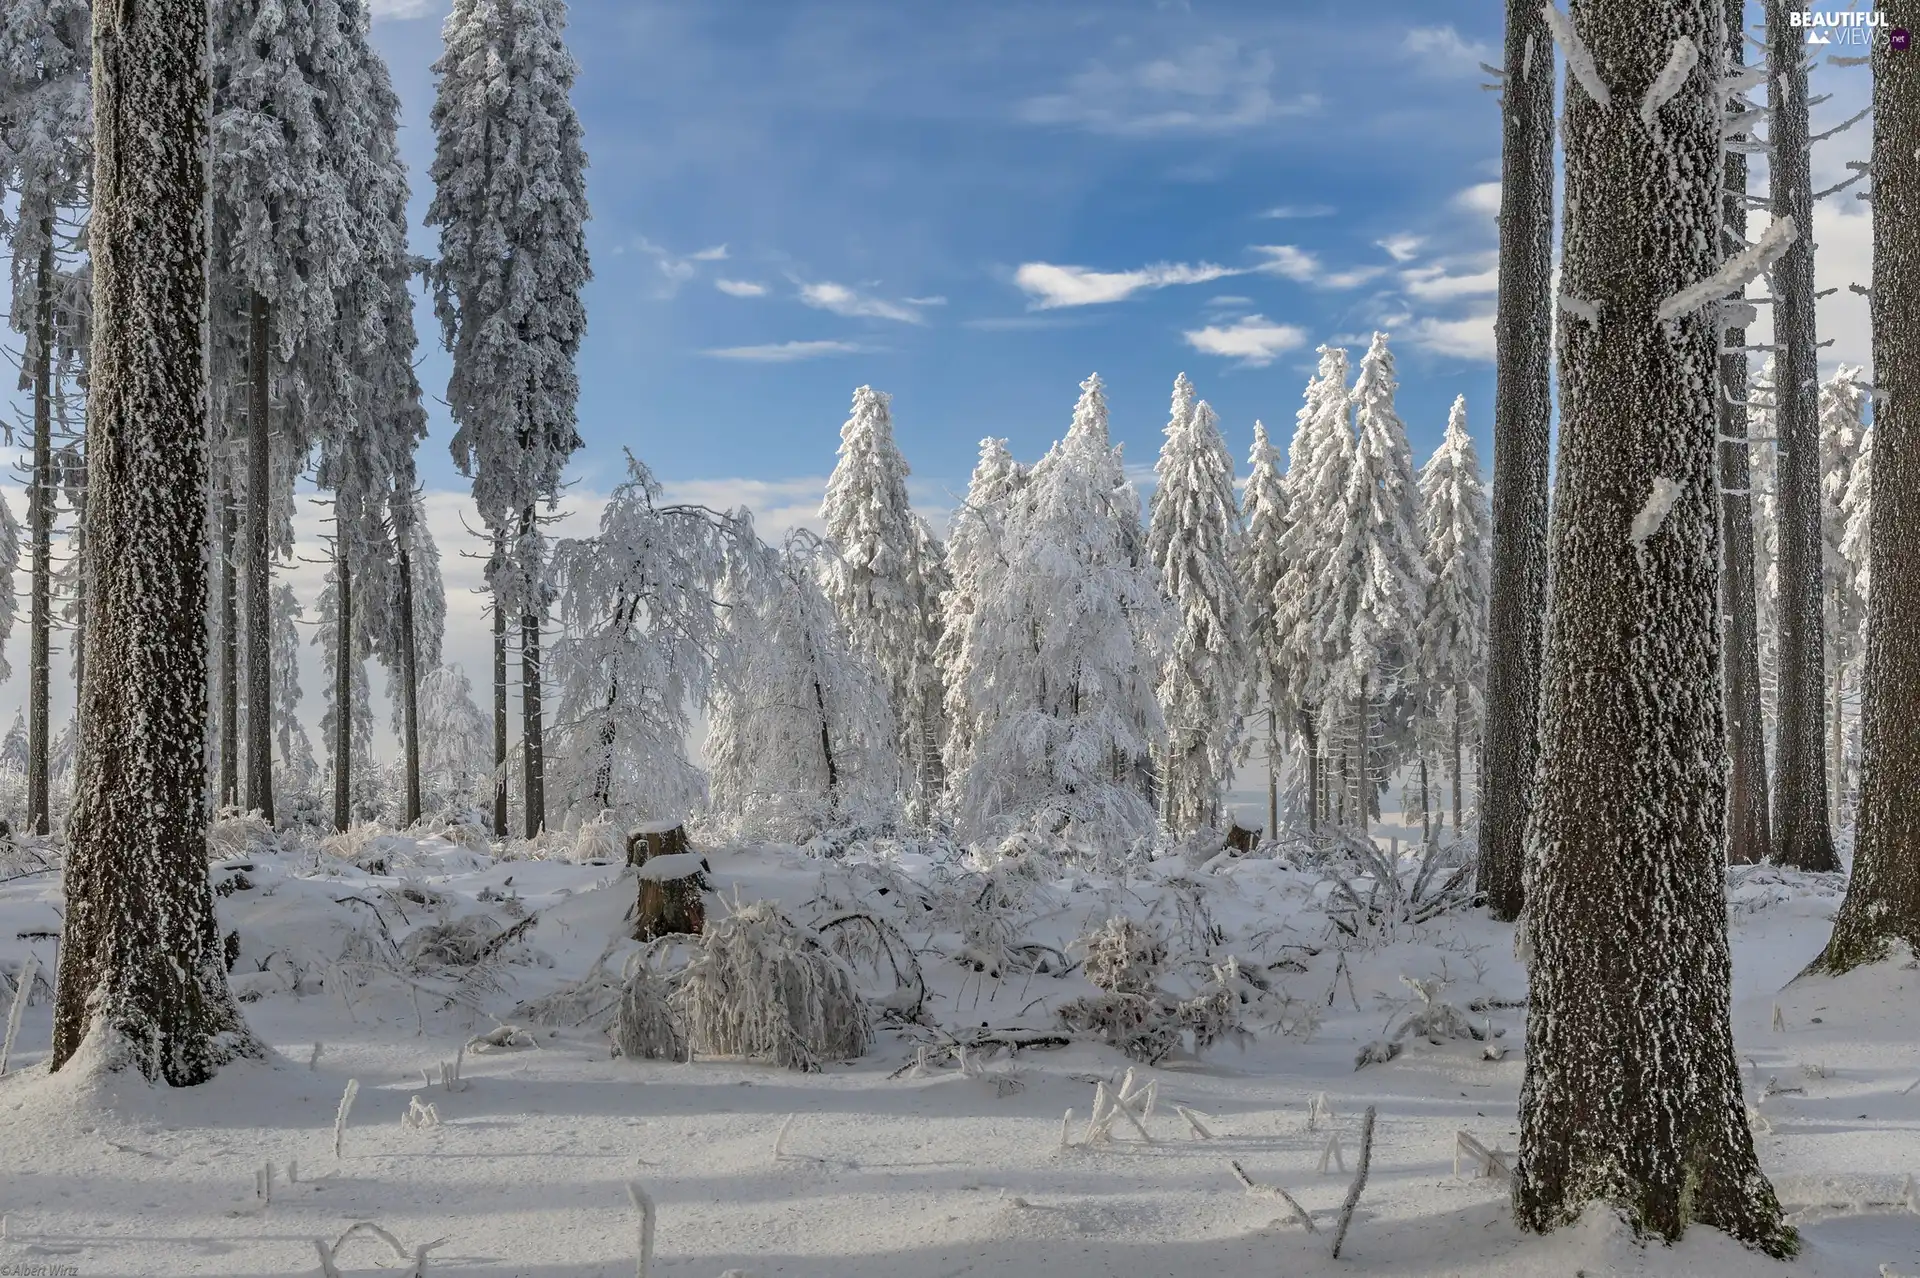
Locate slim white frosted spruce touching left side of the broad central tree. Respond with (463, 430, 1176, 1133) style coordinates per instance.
(935, 439, 1027, 785)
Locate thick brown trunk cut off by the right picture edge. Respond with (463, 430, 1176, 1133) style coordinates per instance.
(1816, 0, 1920, 971)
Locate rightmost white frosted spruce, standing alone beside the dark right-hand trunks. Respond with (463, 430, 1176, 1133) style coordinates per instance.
(1419, 395, 1492, 833)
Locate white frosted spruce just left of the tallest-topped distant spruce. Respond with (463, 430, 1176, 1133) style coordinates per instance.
(1273, 345, 1354, 825)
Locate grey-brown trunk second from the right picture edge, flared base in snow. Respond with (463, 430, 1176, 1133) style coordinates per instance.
(1766, 0, 1839, 869)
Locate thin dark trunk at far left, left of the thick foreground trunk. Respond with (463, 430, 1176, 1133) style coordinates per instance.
(27, 238, 54, 835)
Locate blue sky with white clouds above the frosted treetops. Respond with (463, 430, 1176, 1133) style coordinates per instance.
(362, 0, 1500, 514)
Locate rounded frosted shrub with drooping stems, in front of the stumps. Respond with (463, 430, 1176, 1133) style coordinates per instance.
(670, 902, 872, 1071)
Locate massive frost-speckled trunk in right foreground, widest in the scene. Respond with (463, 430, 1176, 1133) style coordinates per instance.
(1513, 0, 1797, 1255)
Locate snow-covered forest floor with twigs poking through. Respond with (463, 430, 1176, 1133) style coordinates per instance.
(0, 837, 1920, 1278)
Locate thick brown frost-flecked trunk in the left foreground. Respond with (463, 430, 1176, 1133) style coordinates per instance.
(52, 0, 263, 1086)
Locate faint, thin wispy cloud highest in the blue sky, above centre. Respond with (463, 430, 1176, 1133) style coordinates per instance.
(1020, 38, 1319, 136)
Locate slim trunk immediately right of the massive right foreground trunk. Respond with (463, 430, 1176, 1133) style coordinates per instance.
(1718, 0, 1770, 865)
